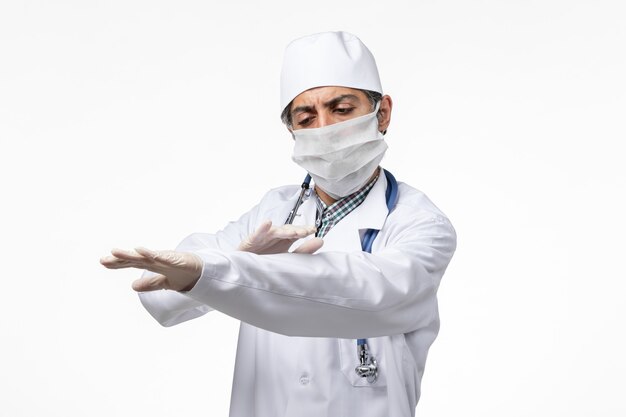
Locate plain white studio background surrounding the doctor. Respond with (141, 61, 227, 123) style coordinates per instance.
(0, 0, 626, 417)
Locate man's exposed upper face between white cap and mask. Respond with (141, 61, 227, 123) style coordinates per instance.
(291, 86, 382, 130)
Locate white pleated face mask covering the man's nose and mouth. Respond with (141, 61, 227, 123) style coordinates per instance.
(291, 103, 387, 199)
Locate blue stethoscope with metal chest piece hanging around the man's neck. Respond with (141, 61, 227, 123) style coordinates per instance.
(285, 169, 398, 384)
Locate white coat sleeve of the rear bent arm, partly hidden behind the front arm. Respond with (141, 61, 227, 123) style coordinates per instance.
(139, 197, 266, 327)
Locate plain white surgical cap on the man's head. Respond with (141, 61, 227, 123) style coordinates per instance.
(280, 32, 383, 111)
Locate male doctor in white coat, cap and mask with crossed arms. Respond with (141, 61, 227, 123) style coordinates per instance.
(101, 32, 456, 417)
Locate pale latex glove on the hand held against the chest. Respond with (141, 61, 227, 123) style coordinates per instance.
(239, 220, 324, 255)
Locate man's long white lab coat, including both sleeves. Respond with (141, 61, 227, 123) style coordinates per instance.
(140, 171, 456, 417)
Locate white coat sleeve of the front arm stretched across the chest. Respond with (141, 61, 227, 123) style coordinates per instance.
(187, 208, 456, 338)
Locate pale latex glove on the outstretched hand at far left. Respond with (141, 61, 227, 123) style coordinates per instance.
(100, 248, 203, 291)
